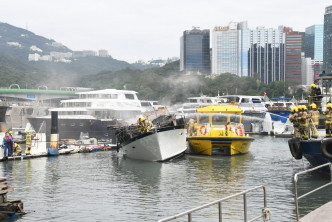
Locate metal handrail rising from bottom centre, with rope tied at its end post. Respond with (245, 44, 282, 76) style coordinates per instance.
(158, 185, 271, 222)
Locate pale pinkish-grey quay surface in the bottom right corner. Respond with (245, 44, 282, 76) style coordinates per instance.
(300, 201, 332, 222)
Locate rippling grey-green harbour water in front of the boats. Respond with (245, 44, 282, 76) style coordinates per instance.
(0, 136, 332, 222)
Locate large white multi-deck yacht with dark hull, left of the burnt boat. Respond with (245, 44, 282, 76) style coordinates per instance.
(29, 89, 141, 143)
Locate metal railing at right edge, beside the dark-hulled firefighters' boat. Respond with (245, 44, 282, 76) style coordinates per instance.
(294, 163, 332, 221)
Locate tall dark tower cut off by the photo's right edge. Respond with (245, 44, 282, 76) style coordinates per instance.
(323, 5, 332, 73)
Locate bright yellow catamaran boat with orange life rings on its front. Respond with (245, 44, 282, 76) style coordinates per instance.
(187, 105, 254, 156)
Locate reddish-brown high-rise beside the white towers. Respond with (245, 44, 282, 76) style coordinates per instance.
(283, 27, 304, 85)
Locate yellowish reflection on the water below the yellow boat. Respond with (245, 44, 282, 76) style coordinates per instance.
(186, 153, 252, 220)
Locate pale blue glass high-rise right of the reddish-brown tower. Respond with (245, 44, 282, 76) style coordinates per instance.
(305, 25, 324, 60)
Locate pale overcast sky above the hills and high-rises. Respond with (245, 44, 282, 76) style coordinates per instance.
(0, 0, 332, 63)
